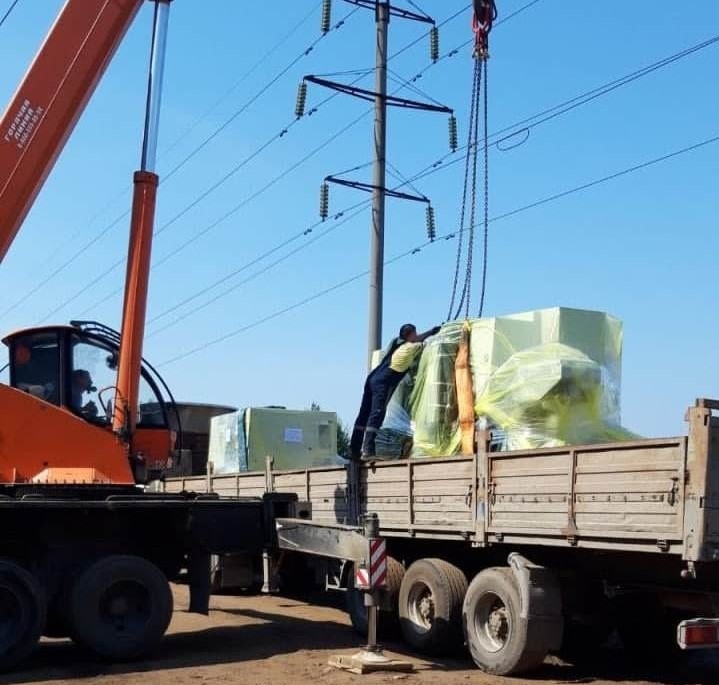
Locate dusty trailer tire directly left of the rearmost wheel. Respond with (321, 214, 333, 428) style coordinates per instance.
(399, 559, 467, 654)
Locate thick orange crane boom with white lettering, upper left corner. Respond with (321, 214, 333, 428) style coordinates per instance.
(0, 0, 143, 262)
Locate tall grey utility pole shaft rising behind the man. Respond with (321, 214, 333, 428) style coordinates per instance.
(368, 2, 390, 365)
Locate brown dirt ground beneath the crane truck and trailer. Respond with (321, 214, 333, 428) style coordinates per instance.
(0, 587, 719, 685)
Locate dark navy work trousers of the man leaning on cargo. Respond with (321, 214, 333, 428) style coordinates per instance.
(350, 367, 404, 459)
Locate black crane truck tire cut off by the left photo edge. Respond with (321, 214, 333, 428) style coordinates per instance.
(0, 559, 45, 671)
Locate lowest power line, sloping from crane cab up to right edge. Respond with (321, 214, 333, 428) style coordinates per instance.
(159, 136, 719, 366)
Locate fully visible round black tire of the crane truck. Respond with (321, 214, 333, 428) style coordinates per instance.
(69, 555, 172, 661)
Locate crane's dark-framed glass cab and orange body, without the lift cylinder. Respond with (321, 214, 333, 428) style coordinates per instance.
(0, 322, 180, 484)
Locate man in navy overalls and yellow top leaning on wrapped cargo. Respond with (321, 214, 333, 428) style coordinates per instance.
(350, 323, 440, 461)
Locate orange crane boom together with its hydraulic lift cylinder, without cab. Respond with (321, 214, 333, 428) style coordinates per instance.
(0, 0, 172, 454)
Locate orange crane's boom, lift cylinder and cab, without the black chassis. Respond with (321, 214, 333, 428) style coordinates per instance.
(0, 0, 174, 486)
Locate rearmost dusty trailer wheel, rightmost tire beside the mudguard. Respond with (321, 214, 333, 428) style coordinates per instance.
(462, 568, 548, 675)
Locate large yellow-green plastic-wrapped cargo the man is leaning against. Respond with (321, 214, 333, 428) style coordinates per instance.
(377, 307, 634, 457)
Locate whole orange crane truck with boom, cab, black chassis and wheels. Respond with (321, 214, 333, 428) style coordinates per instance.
(0, 0, 296, 670)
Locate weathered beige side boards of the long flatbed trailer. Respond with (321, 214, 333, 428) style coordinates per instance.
(163, 400, 719, 562)
